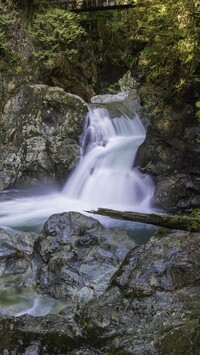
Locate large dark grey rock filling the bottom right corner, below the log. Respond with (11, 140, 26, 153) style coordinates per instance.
(79, 232, 200, 355)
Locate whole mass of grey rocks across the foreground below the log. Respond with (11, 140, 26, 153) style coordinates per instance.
(0, 212, 200, 355)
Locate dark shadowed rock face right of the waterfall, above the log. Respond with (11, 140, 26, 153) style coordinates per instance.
(136, 105, 200, 211)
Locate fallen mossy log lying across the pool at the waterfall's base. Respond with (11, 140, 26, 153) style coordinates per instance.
(86, 208, 200, 232)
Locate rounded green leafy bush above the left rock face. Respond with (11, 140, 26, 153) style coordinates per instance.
(30, 9, 85, 72)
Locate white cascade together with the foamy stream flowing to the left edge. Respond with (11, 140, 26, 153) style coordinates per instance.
(0, 98, 154, 228)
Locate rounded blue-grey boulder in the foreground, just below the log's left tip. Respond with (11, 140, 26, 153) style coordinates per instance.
(37, 212, 134, 307)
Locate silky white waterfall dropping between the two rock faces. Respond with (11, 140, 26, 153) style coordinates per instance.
(63, 106, 152, 211)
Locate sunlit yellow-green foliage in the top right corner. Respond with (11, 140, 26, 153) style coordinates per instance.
(122, 0, 200, 100)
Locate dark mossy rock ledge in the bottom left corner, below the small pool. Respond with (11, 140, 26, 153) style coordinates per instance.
(0, 315, 83, 355)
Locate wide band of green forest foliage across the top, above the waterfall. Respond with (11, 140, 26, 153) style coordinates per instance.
(0, 0, 200, 106)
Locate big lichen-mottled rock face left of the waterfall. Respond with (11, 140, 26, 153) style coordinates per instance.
(0, 85, 87, 189)
